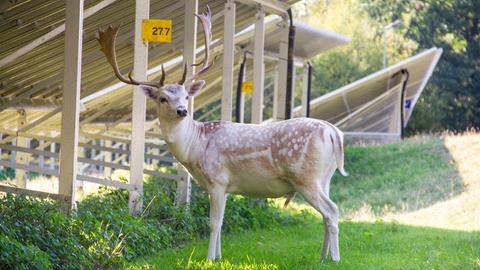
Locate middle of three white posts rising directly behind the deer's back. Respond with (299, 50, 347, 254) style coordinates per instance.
(252, 5, 265, 124)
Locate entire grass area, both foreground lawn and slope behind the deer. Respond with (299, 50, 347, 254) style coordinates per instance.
(130, 134, 480, 269)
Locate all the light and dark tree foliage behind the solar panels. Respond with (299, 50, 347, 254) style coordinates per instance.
(296, 0, 480, 134)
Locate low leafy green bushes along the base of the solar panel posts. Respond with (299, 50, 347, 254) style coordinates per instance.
(0, 173, 302, 269)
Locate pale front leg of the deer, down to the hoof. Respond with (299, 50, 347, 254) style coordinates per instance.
(207, 188, 226, 260)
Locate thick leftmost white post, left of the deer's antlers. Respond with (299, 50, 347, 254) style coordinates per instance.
(58, 0, 83, 212)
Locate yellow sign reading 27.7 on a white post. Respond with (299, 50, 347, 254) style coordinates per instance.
(142, 19, 172, 42)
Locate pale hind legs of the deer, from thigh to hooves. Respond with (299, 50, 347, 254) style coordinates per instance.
(297, 183, 340, 262)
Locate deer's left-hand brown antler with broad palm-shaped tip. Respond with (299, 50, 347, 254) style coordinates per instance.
(97, 25, 165, 87)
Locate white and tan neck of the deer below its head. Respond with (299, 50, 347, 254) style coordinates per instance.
(159, 116, 201, 164)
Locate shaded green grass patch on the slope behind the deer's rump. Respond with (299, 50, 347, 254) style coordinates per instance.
(296, 137, 462, 215)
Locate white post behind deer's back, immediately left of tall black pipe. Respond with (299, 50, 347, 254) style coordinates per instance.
(276, 17, 289, 120)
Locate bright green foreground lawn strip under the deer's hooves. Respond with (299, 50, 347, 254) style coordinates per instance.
(130, 218, 480, 269)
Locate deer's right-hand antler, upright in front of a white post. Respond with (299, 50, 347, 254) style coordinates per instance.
(178, 6, 213, 84)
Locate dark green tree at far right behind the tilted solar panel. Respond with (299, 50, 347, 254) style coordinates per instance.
(362, 0, 480, 132)
